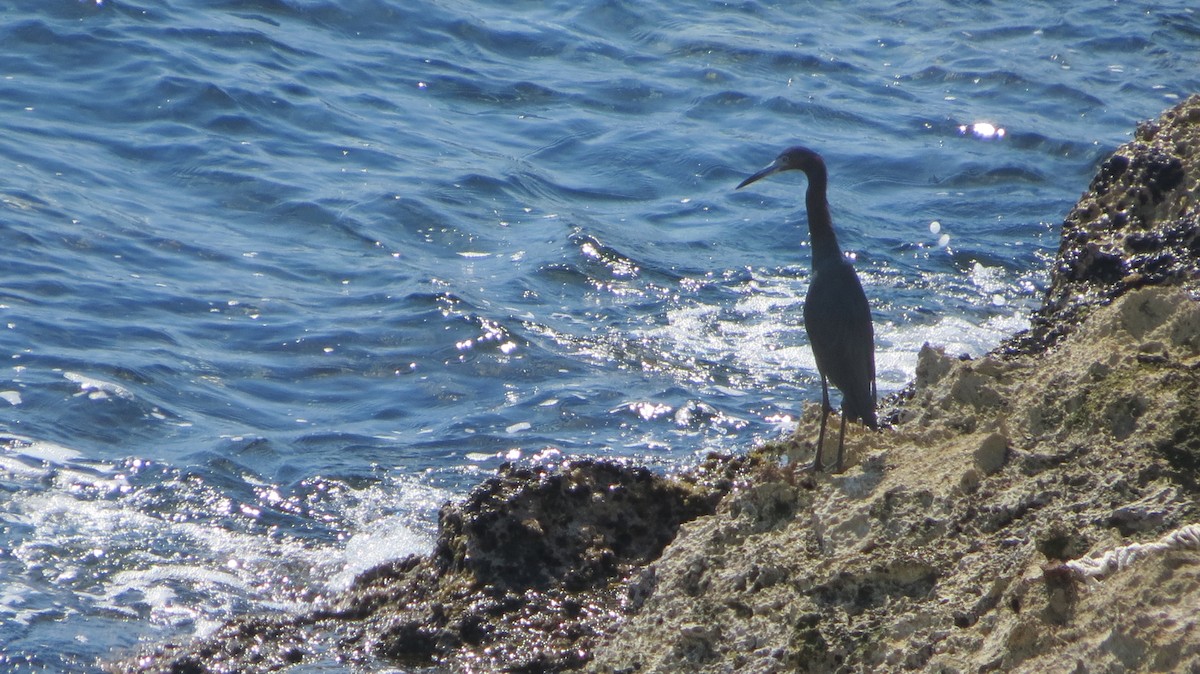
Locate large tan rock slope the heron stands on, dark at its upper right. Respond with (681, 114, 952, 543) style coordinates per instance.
(586, 98, 1200, 674)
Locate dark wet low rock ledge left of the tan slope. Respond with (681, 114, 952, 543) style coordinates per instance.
(108, 458, 751, 674)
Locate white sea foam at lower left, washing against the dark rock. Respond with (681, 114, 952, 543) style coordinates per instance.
(0, 437, 449, 652)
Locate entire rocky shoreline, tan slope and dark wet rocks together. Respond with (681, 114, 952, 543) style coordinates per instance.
(107, 96, 1200, 674)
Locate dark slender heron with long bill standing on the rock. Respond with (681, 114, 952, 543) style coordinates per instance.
(738, 148, 878, 471)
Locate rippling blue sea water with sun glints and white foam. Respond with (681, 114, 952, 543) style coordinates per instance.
(0, 0, 1200, 672)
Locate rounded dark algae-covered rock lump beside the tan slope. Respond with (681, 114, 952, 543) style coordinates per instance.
(433, 461, 714, 591)
